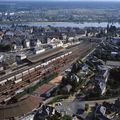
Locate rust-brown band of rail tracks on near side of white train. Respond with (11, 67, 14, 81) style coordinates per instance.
(0, 43, 96, 102)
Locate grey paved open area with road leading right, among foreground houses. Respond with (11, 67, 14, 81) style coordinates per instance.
(55, 97, 117, 115)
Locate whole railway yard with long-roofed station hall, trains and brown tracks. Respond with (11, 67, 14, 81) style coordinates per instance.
(0, 41, 98, 119)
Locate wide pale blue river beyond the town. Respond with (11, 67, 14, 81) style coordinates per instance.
(0, 22, 120, 28)
